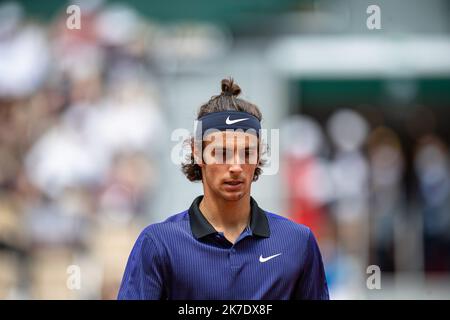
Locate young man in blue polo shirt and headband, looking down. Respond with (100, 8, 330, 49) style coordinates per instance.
(118, 79, 329, 300)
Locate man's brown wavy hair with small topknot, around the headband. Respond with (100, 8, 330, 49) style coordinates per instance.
(181, 78, 265, 182)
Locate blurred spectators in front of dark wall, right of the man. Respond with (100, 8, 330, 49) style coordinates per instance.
(281, 107, 450, 298)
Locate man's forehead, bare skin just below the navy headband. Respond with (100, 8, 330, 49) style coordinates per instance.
(203, 131, 258, 148)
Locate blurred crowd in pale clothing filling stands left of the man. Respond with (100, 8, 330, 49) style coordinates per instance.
(0, 1, 165, 299)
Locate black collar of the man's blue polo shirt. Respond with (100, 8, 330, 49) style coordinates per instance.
(188, 196, 270, 239)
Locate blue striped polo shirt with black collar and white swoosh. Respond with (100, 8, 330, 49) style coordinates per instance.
(118, 196, 329, 300)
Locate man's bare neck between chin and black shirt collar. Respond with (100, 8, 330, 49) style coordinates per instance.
(199, 193, 251, 232)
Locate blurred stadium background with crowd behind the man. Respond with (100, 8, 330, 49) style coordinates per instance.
(0, 0, 450, 299)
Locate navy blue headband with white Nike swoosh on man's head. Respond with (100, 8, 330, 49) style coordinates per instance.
(195, 110, 261, 137)
